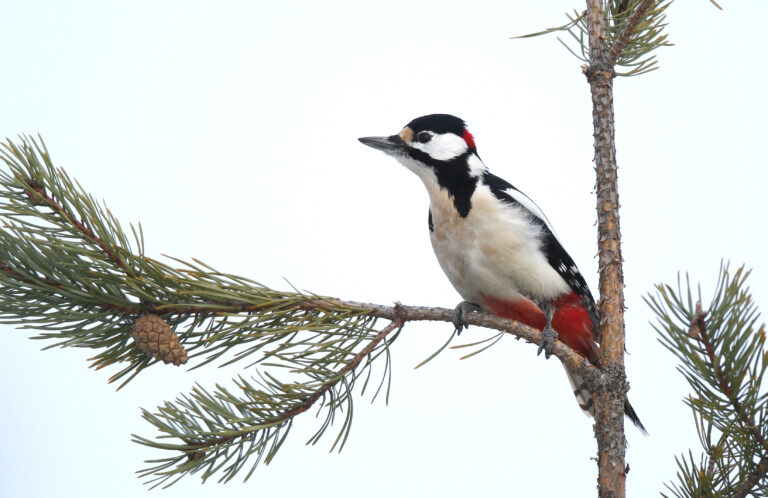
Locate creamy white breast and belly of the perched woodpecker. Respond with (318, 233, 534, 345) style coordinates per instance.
(420, 175, 568, 305)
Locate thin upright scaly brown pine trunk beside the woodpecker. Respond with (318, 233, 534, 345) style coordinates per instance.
(585, 0, 627, 498)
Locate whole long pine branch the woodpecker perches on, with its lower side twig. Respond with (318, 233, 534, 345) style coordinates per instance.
(0, 137, 602, 486)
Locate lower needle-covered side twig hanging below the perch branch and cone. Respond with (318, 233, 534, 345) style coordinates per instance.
(133, 321, 403, 487)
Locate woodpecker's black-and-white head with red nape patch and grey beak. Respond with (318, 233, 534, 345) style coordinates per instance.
(359, 114, 482, 183)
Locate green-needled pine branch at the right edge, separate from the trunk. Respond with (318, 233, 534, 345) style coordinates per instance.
(646, 267, 768, 496)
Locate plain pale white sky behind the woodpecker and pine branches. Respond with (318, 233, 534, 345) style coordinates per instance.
(0, 0, 768, 497)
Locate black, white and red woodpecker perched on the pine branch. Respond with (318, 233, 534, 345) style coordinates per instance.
(359, 114, 645, 433)
